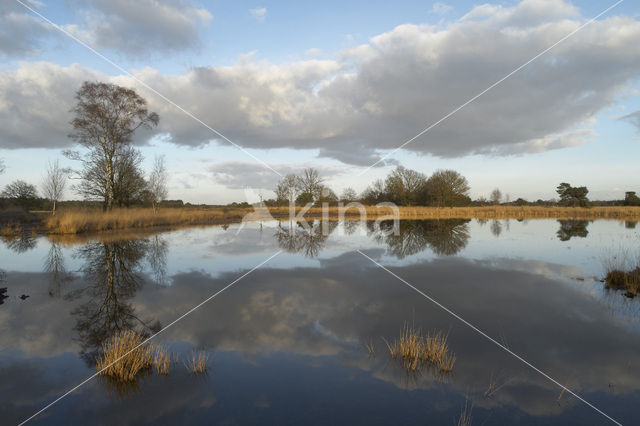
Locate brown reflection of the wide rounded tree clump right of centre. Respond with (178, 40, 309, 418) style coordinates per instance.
(376, 219, 469, 259)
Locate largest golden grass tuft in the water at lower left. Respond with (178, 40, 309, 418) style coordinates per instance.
(96, 331, 153, 382)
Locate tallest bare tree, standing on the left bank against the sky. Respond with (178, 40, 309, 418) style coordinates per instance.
(68, 81, 159, 210)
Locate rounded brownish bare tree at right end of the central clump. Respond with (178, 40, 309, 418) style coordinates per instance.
(425, 170, 471, 207)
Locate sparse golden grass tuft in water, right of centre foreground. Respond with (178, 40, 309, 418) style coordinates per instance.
(386, 324, 456, 372)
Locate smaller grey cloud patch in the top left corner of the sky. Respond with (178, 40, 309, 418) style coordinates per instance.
(0, 0, 213, 58)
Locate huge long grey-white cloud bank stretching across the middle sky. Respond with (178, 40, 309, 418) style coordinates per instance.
(0, 0, 640, 164)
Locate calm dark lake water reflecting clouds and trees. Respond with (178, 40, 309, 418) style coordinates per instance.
(0, 220, 640, 425)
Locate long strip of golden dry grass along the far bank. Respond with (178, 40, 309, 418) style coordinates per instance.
(42, 206, 640, 234)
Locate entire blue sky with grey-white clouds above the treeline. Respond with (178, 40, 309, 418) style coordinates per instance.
(0, 0, 640, 204)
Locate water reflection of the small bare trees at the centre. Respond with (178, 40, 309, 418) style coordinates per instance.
(275, 220, 338, 257)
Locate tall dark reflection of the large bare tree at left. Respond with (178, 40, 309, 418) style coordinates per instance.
(71, 240, 160, 361)
